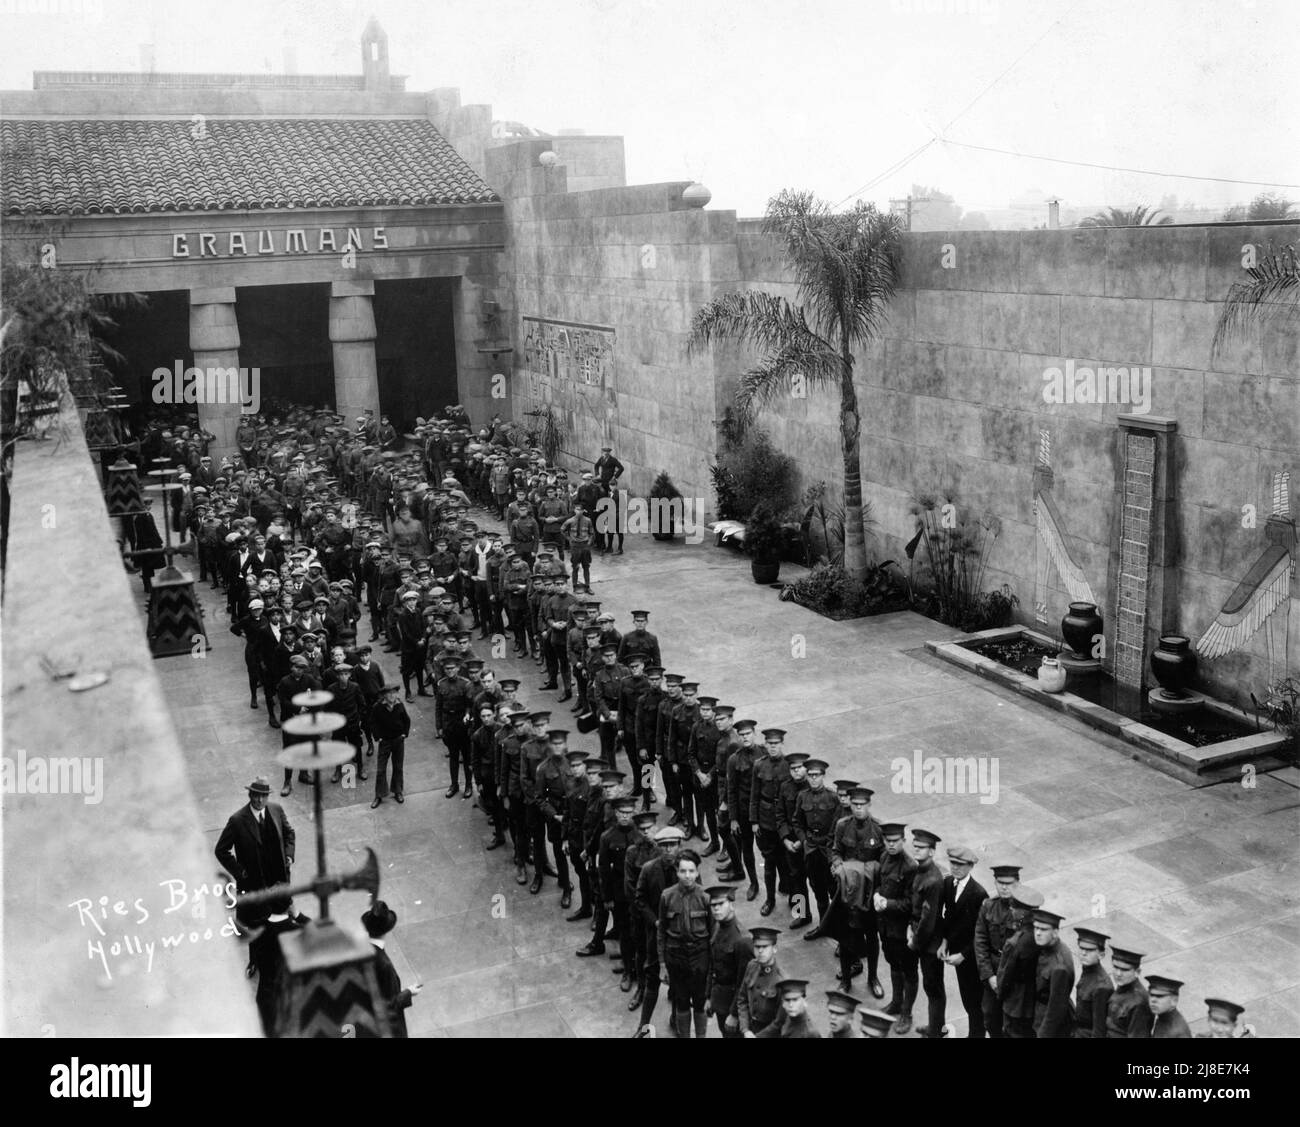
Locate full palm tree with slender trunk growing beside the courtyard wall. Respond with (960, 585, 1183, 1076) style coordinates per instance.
(688, 188, 902, 581)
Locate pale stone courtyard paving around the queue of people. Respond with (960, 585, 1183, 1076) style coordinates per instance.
(157, 527, 1300, 1037)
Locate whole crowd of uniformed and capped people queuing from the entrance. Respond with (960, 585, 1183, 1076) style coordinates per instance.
(131, 407, 1244, 1037)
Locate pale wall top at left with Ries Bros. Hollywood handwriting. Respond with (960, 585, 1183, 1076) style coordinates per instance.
(4, 406, 261, 1037)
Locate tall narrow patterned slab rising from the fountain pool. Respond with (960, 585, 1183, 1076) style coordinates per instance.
(1112, 415, 1179, 689)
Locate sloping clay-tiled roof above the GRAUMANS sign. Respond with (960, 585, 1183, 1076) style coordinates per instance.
(0, 118, 498, 216)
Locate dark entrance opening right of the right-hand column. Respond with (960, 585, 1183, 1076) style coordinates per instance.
(374, 278, 460, 432)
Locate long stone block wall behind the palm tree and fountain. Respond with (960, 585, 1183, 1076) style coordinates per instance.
(738, 222, 1300, 701)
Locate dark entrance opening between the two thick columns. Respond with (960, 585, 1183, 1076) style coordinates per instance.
(235, 283, 334, 412)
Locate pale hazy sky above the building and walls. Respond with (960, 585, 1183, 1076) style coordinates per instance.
(0, 0, 1300, 216)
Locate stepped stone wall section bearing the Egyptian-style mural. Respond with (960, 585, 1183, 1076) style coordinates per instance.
(488, 138, 738, 500)
